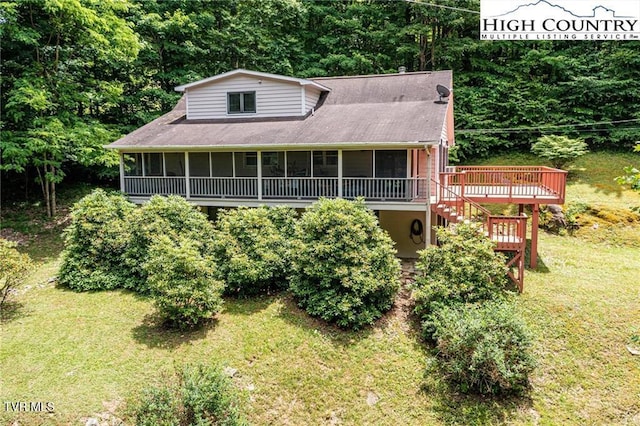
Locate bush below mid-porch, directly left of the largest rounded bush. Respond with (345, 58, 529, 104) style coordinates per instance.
(214, 207, 296, 295)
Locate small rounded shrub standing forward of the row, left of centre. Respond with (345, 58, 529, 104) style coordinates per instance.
(145, 235, 224, 329)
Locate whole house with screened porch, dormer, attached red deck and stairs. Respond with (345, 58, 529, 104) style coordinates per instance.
(108, 69, 565, 292)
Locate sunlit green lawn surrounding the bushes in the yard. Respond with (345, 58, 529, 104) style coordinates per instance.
(0, 154, 640, 425)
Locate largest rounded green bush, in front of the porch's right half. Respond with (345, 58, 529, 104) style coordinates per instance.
(290, 199, 400, 329)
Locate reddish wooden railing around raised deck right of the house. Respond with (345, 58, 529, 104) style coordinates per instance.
(440, 166, 567, 204)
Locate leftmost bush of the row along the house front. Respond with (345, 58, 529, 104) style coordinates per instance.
(59, 189, 135, 291)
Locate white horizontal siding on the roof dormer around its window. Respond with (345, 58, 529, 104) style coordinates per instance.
(187, 76, 302, 120)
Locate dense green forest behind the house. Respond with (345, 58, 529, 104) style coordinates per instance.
(0, 0, 640, 210)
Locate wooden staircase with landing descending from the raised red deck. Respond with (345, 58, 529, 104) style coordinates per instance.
(431, 180, 528, 292)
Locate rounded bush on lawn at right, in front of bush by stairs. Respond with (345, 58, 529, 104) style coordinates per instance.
(432, 301, 535, 394)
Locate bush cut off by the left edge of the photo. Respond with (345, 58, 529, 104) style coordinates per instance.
(0, 238, 33, 313)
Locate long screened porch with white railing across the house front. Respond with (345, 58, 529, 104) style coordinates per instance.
(121, 150, 427, 202)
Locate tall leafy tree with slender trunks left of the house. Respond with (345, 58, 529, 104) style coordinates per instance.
(0, 0, 139, 216)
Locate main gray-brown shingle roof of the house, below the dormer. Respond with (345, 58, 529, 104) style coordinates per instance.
(108, 71, 452, 150)
